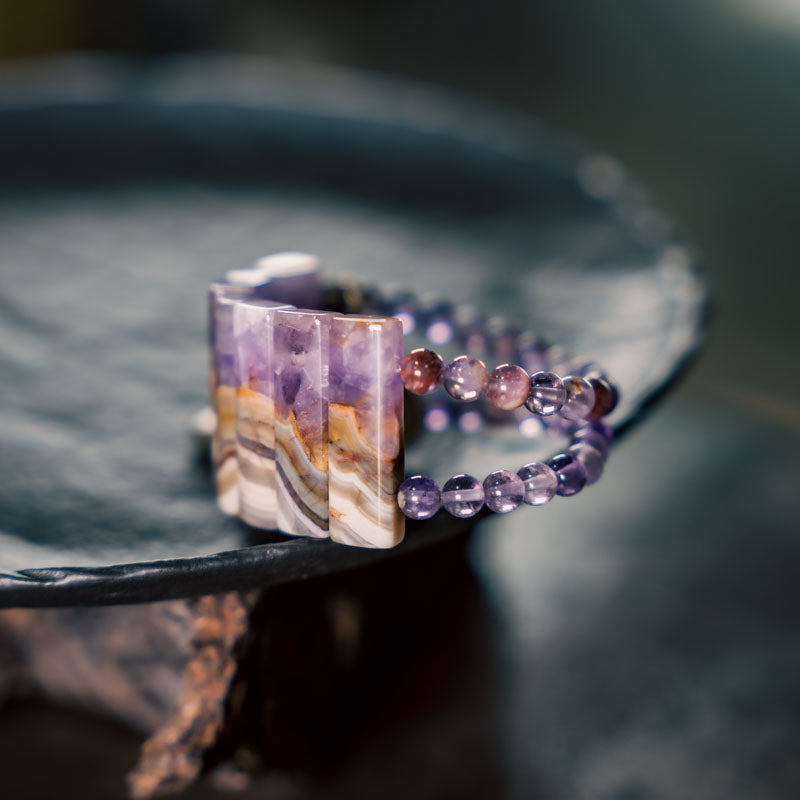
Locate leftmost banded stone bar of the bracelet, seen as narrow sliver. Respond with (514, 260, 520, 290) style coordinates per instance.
(208, 283, 256, 514)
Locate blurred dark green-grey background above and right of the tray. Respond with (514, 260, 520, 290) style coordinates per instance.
(0, 0, 800, 800)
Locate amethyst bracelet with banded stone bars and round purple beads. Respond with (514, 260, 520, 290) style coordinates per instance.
(208, 253, 618, 548)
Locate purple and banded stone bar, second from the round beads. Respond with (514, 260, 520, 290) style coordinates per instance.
(272, 309, 331, 538)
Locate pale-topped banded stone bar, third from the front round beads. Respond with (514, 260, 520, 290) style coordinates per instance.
(233, 299, 292, 530)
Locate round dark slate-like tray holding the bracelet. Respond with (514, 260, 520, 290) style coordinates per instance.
(0, 58, 704, 606)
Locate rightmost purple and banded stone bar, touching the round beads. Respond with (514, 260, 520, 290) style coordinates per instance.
(328, 315, 405, 548)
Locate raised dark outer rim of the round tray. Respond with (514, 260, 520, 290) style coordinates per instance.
(0, 54, 708, 608)
